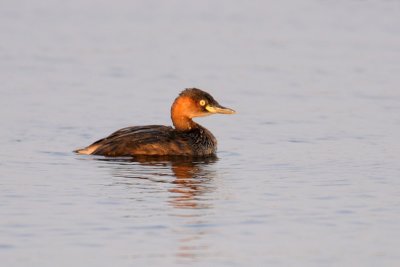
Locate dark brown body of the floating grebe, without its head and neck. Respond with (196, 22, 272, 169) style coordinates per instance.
(78, 125, 217, 157)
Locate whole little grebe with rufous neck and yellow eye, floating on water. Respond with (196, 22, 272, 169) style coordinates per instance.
(75, 88, 235, 157)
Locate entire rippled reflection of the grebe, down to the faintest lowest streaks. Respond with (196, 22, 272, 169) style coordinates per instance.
(92, 156, 218, 263)
